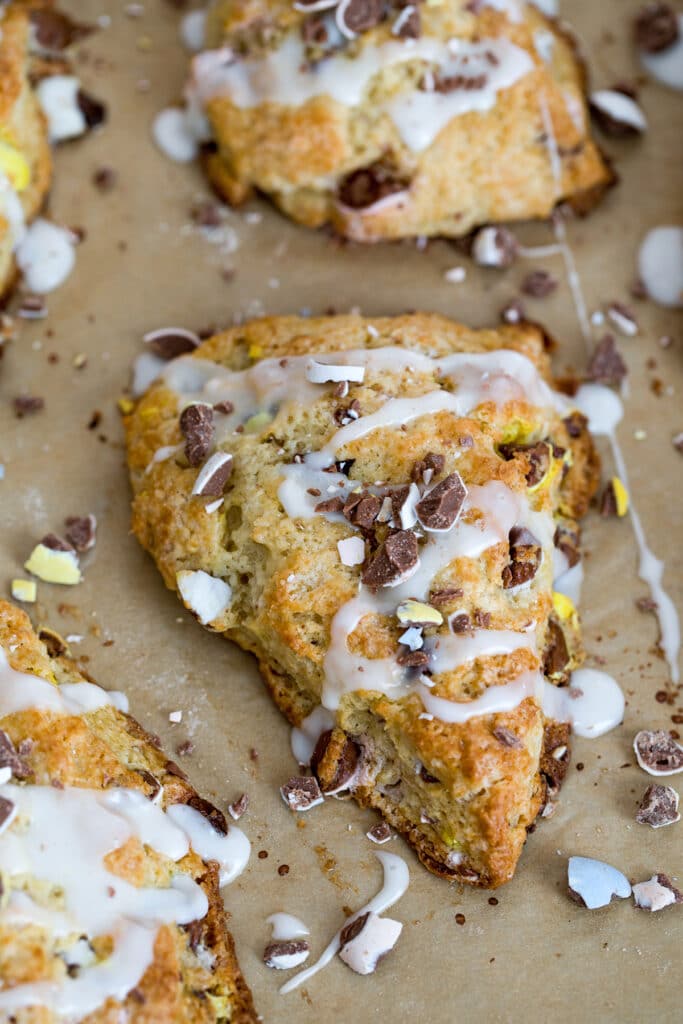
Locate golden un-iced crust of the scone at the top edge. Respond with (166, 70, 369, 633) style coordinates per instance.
(196, 0, 615, 242)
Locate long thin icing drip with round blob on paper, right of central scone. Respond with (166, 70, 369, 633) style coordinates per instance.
(575, 384, 681, 683)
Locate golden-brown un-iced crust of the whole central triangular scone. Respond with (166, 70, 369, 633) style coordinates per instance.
(126, 314, 598, 886)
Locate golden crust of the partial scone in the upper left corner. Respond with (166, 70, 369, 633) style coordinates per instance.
(0, 3, 52, 299)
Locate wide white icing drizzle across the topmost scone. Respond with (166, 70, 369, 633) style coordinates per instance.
(187, 33, 533, 152)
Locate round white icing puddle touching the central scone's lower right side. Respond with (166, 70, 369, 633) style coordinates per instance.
(543, 669, 625, 739)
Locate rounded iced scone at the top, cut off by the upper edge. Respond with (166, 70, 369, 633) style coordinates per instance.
(187, 0, 613, 242)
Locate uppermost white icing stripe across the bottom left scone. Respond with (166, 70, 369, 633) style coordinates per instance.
(0, 647, 128, 718)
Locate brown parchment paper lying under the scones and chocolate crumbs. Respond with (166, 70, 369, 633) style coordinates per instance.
(0, 0, 683, 1024)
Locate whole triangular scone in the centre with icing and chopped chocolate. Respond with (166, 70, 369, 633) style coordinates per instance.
(127, 314, 597, 886)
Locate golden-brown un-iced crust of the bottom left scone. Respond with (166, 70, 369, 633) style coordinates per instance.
(0, 601, 257, 1024)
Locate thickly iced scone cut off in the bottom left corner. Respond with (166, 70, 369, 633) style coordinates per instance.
(0, 601, 256, 1024)
